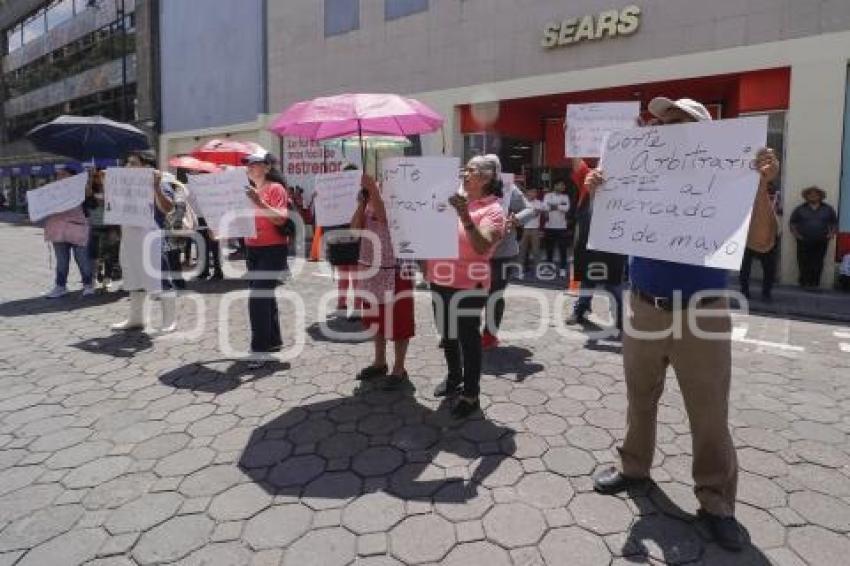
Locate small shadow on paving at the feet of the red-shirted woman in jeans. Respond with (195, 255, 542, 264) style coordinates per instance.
(159, 359, 290, 395)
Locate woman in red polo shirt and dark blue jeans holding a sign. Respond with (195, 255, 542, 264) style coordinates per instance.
(242, 151, 289, 369)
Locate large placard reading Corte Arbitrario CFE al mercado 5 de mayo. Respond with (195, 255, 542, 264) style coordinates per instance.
(588, 117, 767, 269)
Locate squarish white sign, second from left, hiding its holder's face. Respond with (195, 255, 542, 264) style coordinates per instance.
(103, 167, 155, 228)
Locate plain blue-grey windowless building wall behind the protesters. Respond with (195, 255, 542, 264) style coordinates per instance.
(159, 0, 273, 161)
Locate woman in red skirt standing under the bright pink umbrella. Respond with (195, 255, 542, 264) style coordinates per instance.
(351, 175, 415, 390)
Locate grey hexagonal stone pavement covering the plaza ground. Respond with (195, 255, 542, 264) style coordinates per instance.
(0, 220, 850, 566)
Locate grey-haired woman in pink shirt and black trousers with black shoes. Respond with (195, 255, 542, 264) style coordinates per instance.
(425, 155, 505, 419)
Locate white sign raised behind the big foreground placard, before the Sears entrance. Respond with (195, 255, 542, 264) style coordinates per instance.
(564, 101, 640, 157)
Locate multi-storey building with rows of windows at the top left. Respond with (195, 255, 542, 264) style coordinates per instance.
(0, 0, 158, 208)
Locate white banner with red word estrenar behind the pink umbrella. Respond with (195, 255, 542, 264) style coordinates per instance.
(282, 137, 363, 203)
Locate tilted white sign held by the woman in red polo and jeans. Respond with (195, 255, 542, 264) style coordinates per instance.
(189, 167, 257, 239)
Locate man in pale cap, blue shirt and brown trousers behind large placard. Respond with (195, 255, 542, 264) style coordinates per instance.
(585, 98, 779, 551)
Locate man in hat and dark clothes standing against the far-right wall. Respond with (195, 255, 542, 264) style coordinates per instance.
(791, 187, 838, 288)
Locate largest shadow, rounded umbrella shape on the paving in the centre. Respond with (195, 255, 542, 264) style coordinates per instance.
(239, 382, 516, 509)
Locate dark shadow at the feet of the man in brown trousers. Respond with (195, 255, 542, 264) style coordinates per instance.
(621, 483, 771, 566)
